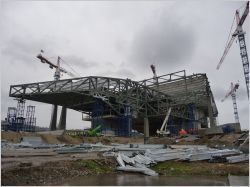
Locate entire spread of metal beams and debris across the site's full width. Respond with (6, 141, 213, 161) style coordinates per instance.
(2, 140, 248, 176)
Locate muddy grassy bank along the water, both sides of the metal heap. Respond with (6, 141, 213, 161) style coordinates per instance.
(1, 159, 249, 186)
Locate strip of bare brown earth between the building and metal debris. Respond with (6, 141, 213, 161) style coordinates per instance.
(1, 132, 246, 146)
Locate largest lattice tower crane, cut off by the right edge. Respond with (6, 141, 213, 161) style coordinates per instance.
(216, 1, 249, 99)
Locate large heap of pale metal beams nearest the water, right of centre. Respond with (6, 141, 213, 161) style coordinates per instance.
(103, 144, 246, 176)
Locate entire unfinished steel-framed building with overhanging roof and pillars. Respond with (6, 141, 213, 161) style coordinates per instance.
(9, 70, 218, 139)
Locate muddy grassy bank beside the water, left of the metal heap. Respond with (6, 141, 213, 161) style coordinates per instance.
(1, 159, 116, 186)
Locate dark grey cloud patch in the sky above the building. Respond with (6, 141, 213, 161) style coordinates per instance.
(131, 15, 196, 68)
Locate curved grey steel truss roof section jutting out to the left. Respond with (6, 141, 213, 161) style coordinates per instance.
(9, 76, 176, 116)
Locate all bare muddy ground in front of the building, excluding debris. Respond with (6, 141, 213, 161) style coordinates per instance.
(1, 132, 249, 185)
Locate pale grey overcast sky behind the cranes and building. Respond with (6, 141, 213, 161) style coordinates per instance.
(0, 1, 249, 129)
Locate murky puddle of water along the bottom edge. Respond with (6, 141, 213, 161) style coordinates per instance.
(60, 173, 228, 186)
